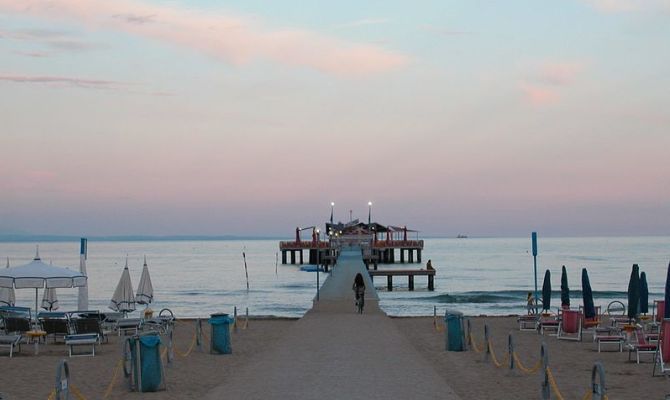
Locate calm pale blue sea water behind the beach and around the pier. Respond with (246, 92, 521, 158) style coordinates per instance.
(0, 237, 670, 316)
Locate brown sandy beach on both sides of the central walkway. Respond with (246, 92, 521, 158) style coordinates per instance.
(0, 311, 670, 399)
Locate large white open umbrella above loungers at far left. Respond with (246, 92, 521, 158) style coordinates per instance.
(0, 247, 86, 315)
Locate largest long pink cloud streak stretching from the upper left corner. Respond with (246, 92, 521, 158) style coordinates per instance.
(0, 0, 408, 76)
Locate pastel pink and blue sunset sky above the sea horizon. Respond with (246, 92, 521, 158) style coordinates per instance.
(0, 0, 670, 237)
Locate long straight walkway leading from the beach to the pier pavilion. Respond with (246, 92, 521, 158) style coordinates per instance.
(205, 251, 459, 400)
